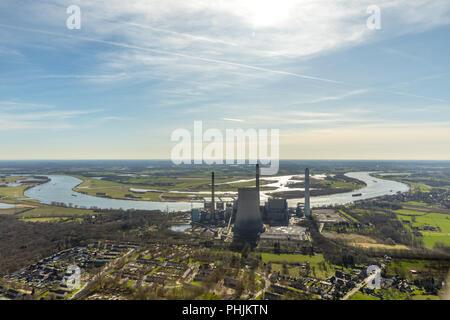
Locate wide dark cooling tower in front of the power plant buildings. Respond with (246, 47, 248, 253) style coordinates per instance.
(234, 188, 263, 238)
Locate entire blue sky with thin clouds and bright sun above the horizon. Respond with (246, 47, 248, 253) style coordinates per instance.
(0, 0, 450, 160)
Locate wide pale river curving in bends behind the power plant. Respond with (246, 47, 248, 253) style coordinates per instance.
(25, 172, 409, 211)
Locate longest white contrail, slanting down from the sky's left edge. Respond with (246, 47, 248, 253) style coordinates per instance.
(0, 24, 344, 84)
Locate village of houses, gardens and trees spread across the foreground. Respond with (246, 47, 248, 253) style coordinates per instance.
(0, 242, 432, 300)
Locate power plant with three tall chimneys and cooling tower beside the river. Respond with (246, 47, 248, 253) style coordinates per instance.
(191, 164, 311, 243)
